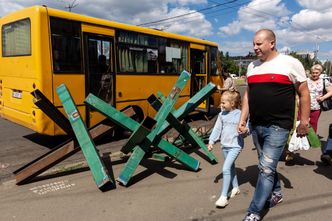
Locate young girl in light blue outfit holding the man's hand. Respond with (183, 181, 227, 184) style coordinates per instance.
(208, 91, 247, 207)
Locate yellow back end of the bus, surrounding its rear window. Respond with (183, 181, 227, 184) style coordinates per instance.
(0, 8, 53, 134)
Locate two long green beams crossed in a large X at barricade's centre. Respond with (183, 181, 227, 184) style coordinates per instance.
(86, 71, 199, 185)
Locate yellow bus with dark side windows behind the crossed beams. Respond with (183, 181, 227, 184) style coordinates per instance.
(0, 6, 222, 135)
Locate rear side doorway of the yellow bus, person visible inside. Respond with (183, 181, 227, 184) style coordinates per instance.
(83, 28, 115, 127)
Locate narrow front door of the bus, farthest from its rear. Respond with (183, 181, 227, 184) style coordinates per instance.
(190, 44, 208, 111)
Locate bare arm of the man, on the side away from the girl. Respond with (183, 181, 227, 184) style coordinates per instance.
(296, 81, 310, 137)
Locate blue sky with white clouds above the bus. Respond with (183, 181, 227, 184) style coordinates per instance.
(0, 0, 332, 61)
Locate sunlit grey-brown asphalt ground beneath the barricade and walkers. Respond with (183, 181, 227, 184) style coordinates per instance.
(0, 93, 332, 221)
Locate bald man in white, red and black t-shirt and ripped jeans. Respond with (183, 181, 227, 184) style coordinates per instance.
(238, 29, 310, 221)
